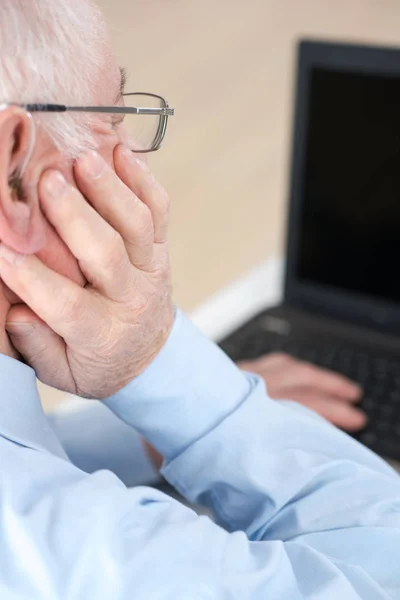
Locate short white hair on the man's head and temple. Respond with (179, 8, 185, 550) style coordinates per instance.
(0, 0, 107, 157)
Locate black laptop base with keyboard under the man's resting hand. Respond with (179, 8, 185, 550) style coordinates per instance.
(220, 305, 400, 460)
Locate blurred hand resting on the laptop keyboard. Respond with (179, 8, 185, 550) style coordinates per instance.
(239, 354, 366, 431)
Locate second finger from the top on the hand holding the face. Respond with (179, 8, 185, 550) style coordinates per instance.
(75, 150, 154, 270)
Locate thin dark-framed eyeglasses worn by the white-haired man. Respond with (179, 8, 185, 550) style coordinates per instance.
(19, 92, 175, 153)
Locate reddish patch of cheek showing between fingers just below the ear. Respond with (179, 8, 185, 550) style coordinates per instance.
(37, 221, 87, 287)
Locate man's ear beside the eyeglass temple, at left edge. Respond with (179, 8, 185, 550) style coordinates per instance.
(0, 106, 45, 254)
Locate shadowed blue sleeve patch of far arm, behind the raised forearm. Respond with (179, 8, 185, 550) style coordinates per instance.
(47, 400, 161, 487)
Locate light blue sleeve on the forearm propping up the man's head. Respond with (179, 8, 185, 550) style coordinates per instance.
(102, 312, 400, 598)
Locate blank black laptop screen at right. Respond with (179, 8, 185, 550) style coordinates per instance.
(296, 69, 400, 302)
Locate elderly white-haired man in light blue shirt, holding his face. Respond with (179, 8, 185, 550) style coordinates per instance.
(0, 0, 400, 600)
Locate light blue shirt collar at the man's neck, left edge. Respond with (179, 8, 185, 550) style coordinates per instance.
(0, 354, 67, 458)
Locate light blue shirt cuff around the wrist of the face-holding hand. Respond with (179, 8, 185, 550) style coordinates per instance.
(104, 310, 252, 460)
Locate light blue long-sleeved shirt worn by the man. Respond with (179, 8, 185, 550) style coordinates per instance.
(0, 312, 400, 600)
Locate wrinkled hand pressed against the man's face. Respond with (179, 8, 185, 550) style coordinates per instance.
(0, 146, 174, 398)
